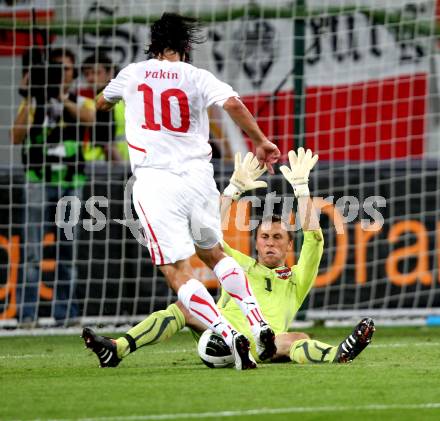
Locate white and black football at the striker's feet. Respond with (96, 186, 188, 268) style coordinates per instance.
(197, 330, 234, 368)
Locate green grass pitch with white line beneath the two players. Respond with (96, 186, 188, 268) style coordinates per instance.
(0, 327, 440, 421)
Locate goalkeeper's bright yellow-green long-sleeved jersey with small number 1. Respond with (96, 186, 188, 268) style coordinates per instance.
(218, 230, 324, 348)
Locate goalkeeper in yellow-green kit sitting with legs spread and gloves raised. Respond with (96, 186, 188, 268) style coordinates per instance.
(83, 148, 375, 367)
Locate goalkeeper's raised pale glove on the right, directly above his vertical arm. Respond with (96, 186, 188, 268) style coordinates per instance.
(280, 148, 319, 197)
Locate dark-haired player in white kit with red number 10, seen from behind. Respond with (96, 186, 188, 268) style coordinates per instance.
(83, 13, 280, 369)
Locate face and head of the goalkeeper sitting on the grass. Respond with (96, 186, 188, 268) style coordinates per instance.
(255, 221, 293, 268)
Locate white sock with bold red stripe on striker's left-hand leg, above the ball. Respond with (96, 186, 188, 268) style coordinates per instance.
(177, 279, 232, 346)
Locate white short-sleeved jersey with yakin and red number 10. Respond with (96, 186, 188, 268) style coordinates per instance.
(103, 59, 238, 173)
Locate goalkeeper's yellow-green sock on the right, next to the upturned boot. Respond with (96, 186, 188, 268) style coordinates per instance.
(289, 339, 338, 364)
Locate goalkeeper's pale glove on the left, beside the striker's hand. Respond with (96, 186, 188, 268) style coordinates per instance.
(223, 152, 267, 200)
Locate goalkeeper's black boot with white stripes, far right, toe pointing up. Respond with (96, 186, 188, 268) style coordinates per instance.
(333, 317, 376, 363)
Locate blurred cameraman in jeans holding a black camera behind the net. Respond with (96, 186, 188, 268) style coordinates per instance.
(11, 48, 95, 327)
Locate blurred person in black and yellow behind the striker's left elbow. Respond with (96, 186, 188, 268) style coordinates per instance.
(79, 53, 128, 161)
